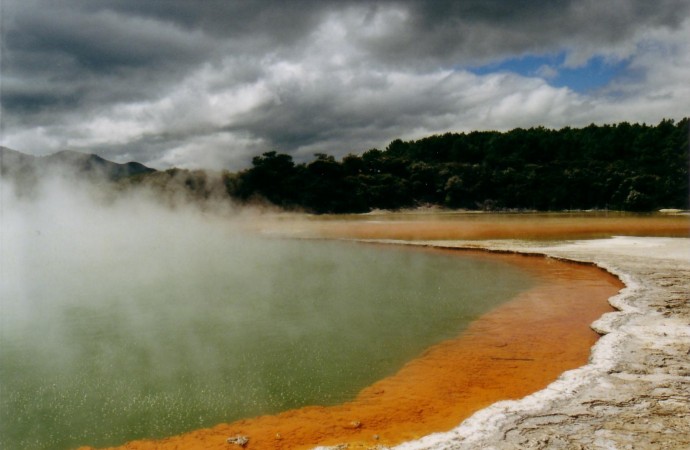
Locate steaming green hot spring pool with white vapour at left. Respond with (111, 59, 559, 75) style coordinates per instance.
(0, 174, 531, 449)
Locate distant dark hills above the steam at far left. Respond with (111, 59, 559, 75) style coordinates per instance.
(0, 147, 156, 181)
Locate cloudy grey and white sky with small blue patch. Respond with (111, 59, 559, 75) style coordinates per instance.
(0, 0, 690, 170)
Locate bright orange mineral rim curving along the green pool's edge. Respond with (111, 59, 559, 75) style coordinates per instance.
(88, 250, 622, 449)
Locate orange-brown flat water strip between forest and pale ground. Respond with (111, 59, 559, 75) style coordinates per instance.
(262, 211, 690, 240)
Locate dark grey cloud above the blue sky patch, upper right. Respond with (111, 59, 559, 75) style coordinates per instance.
(354, 0, 690, 66)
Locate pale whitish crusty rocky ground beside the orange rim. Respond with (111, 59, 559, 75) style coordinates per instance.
(362, 237, 690, 450)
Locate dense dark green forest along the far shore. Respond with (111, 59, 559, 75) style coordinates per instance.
(224, 118, 689, 213)
